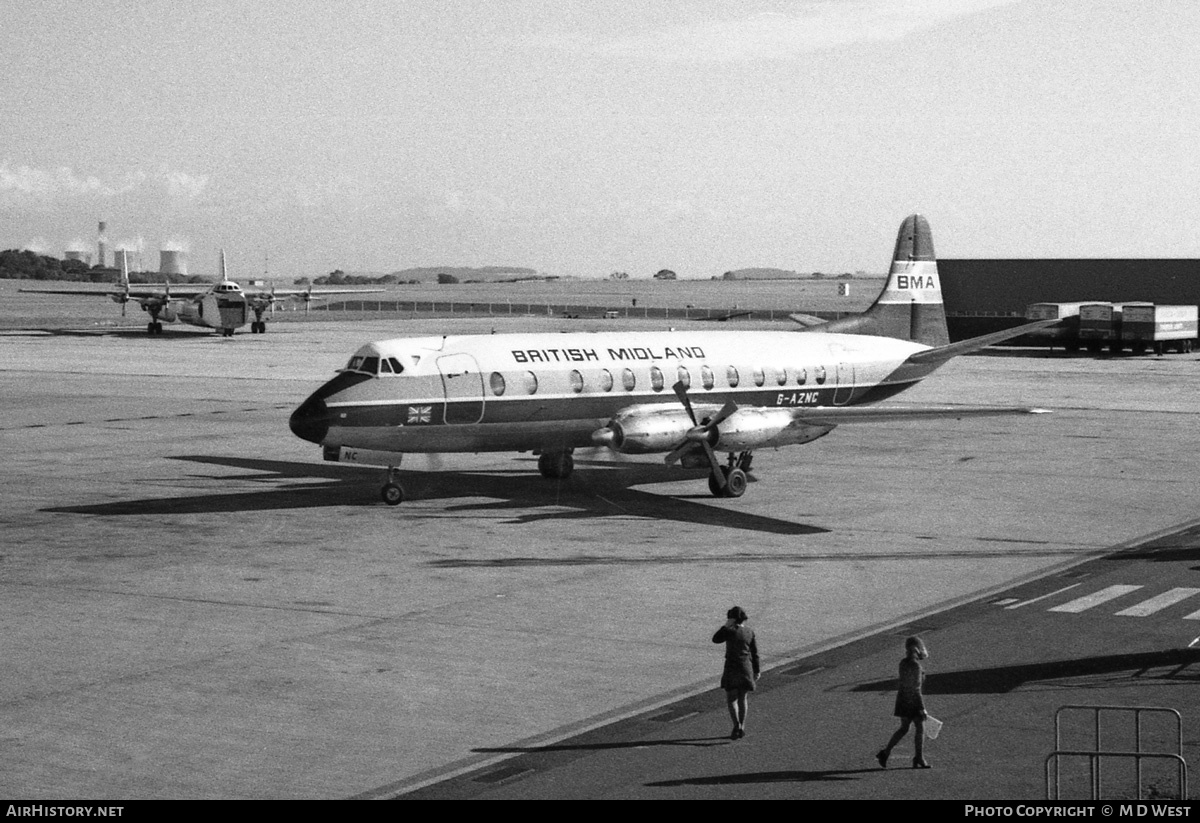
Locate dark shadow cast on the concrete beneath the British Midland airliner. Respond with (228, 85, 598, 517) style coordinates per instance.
(41, 455, 828, 535)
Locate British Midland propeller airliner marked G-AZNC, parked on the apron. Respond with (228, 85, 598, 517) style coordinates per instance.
(290, 215, 1055, 505)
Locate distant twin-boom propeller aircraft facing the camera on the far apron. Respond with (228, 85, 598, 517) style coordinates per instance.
(20, 251, 384, 337)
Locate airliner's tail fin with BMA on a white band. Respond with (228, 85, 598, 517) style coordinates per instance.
(805, 215, 950, 347)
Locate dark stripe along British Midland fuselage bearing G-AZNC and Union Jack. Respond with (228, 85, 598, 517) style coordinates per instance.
(328, 380, 916, 428)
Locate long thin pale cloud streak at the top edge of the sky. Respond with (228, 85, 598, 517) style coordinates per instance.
(551, 0, 1020, 62)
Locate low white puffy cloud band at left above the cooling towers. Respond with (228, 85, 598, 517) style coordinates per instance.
(0, 160, 209, 204)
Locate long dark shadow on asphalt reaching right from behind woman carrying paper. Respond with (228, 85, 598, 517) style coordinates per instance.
(850, 649, 1200, 695)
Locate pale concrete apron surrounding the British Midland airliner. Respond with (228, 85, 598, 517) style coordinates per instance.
(0, 319, 1200, 799)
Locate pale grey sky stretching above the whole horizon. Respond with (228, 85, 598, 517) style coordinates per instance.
(0, 0, 1200, 278)
